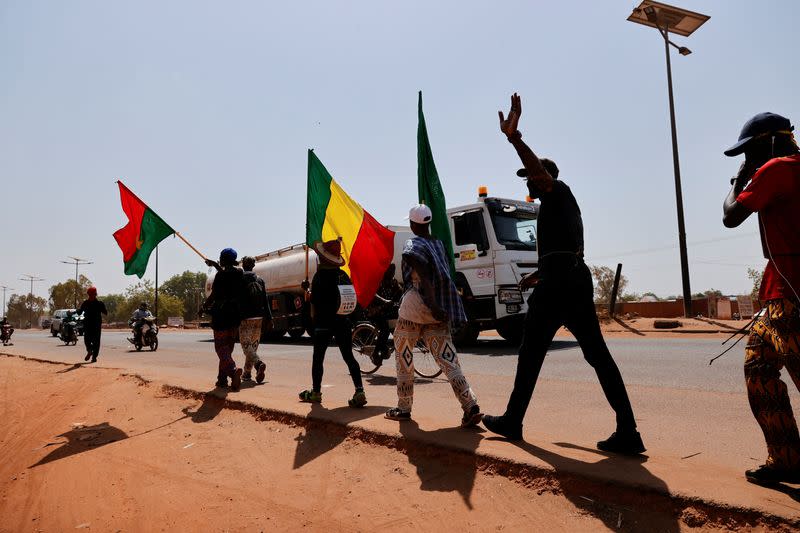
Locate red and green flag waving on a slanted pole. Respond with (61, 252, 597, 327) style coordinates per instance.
(114, 181, 175, 278)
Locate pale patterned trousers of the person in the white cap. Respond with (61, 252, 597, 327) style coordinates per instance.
(394, 318, 478, 412)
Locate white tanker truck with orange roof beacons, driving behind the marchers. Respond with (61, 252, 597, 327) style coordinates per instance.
(206, 187, 539, 345)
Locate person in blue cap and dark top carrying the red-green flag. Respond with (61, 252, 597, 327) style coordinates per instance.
(203, 248, 242, 391)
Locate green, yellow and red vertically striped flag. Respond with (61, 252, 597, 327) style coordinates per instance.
(306, 150, 394, 307)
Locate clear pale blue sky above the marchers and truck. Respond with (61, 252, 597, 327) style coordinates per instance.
(0, 0, 800, 297)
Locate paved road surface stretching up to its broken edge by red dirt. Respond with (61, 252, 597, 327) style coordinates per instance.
(0, 330, 800, 516)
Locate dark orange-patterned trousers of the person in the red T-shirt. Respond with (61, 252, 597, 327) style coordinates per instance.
(744, 298, 800, 468)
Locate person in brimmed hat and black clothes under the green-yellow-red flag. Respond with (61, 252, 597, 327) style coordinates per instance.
(299, 239, 367, 407)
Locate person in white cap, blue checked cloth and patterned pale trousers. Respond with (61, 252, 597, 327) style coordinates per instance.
(386, 204, 482, 427)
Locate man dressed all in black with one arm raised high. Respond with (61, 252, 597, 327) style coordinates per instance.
(483, 93, 645, 454)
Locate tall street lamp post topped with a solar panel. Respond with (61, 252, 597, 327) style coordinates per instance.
(628, 0, 711, 317)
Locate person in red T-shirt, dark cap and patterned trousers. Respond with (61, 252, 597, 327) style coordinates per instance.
(722, 113, 800, 484)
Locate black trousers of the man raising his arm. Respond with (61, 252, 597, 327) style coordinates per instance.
(505, 260, 636, 431)
